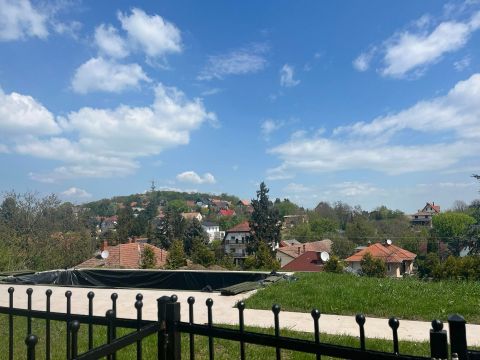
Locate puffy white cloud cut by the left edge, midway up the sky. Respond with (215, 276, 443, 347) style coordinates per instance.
(0, 88, 60, 137)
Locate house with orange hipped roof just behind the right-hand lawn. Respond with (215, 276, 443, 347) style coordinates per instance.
(345, 241, 417, 277)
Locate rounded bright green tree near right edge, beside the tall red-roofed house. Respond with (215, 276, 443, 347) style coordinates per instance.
(432, 212, 475, 255)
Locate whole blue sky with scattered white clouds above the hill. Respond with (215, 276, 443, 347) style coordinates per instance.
(0, 0, 480, 212)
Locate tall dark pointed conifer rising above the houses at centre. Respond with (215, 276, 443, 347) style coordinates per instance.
(249, 182, 282, 251)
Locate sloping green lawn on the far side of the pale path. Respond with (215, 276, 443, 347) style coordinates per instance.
(246, 272, 480, 324)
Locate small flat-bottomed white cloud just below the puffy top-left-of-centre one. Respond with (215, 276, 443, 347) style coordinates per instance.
(72, 57, 150, 94)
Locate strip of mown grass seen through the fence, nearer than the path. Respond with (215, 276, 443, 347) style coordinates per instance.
(0, 315, 429, 360)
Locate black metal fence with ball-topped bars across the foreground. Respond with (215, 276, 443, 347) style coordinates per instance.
(0, 287, 480, 360)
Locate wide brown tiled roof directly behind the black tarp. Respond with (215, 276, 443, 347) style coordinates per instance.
(76, 243, 168, 269)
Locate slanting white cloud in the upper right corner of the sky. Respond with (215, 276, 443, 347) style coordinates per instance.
(353, 12, 480, 78)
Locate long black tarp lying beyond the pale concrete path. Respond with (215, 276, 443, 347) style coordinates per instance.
(3, 269, 268, 291)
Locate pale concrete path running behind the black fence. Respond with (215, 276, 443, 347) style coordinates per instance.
(0, 284, 480, 346)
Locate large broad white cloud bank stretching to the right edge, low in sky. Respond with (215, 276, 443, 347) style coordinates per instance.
(267, 74, 480, 179)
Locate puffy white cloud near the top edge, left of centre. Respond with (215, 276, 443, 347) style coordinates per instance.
(118, 8, 182, 57)
